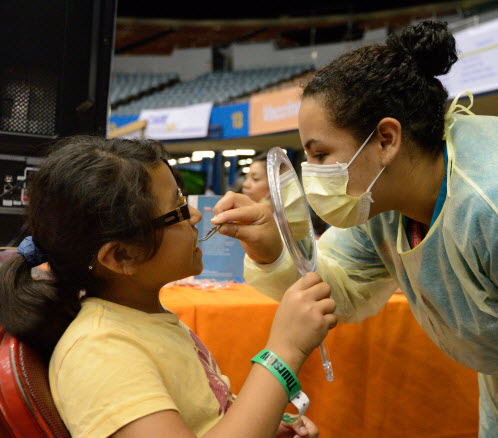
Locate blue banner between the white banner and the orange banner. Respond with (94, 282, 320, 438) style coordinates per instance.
(209, 102, 249, 138)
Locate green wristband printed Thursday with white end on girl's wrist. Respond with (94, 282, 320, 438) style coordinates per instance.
(251, 350, 310, 423)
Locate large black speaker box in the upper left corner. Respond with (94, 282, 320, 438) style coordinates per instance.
(0, 0, 117, 155)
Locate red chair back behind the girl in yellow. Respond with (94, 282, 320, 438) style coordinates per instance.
(0, 327, 71, 438)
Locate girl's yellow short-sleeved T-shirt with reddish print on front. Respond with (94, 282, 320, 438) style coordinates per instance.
(49, 298, 233, 438)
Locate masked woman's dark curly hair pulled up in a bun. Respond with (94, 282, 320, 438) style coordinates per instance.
(302, 21, 458, 154)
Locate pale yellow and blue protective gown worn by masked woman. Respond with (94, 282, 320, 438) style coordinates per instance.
(244, 110, 498, 438)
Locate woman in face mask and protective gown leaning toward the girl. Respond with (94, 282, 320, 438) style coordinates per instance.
(212, 22, 498, 438)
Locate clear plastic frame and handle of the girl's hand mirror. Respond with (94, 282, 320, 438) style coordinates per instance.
(267, 147, 334, 382)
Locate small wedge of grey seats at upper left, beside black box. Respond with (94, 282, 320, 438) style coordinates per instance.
(109, 73, 178, 106)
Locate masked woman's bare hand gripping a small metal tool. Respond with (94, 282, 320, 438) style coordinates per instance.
(211, 192, 283, 264)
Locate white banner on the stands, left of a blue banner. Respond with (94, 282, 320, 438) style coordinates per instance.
(138, 102, 213, 140)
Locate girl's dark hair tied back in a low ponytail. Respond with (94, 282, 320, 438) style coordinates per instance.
(0, 136, 167, 361)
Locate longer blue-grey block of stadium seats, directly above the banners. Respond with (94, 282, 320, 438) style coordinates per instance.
(112, 64, 314, 115)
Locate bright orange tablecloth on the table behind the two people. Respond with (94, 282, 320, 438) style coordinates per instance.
(160, 284, 478, 438)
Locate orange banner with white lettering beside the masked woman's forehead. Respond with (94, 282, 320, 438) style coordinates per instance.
(249, 87, 301, 135)
